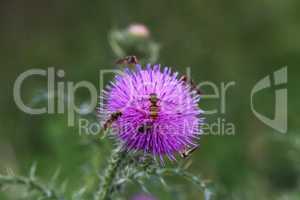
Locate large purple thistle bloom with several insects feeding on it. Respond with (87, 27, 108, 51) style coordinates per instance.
(100, 65, 202, 160)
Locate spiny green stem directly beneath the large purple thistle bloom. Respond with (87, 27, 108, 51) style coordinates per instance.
(94, 148, 125, 200)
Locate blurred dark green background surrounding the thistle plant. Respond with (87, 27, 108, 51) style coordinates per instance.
(0, 0, 300, 200)
